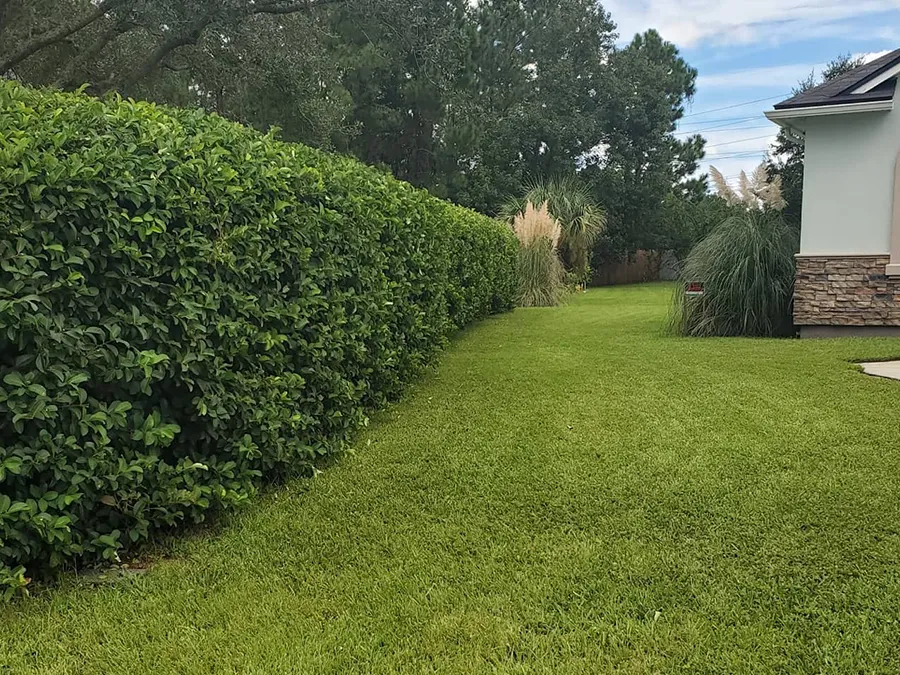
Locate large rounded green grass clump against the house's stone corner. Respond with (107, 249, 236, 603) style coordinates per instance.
(670, 210, 797, 337)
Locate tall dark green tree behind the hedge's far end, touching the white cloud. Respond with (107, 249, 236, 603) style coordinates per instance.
(449, 0, 615, 213)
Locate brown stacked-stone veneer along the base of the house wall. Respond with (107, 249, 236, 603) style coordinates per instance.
(794, 254, 900, 326)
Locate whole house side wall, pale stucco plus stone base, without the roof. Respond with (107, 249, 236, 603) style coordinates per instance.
(794, 87, 900, 337)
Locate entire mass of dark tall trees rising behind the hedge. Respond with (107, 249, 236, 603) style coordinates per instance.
(0, 0, 703, 243)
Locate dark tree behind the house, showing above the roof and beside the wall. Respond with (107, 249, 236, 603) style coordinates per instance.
(768, 54, 865, 228)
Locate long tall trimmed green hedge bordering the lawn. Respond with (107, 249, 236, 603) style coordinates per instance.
(0, 82, 517, 595)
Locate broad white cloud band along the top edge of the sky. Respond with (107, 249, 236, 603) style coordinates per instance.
(604, 0, 900, 47)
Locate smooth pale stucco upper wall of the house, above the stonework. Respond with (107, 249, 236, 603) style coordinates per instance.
(800, 87, 900, 255)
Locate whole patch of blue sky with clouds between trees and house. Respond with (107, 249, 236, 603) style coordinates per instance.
(603, 0, 900, 181)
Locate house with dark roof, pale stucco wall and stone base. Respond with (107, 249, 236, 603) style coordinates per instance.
(766, 49, 900, 337)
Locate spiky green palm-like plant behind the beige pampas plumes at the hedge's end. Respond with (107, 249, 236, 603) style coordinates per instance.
(500, 176, 606, 284)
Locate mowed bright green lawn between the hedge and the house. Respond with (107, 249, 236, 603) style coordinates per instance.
(0, 286, 900, 675)
